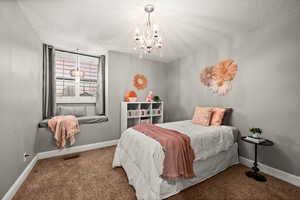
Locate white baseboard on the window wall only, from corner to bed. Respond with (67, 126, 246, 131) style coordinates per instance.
(37, 140, 119, 159)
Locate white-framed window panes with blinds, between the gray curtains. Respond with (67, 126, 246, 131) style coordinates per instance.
(55, 50, 101, 104)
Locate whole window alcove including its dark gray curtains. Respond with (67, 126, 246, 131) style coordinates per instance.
(42, 44, 108, 123)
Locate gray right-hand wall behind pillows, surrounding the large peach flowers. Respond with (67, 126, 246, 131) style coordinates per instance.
(166, 12, 300, 176)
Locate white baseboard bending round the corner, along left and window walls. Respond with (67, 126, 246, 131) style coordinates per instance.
(2, 140, 119, 200)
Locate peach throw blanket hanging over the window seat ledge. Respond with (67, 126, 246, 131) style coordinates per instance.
(48, 115, 80, 148)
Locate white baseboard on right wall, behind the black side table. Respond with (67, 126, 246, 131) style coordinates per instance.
(239, 156, 300, 187)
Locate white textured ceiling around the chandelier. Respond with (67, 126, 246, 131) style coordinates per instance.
(18, 0, 300, 62)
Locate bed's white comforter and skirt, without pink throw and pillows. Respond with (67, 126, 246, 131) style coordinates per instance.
(113, 120, 238, 200)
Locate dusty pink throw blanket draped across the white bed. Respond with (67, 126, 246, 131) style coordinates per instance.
(133, 124, 195, 179)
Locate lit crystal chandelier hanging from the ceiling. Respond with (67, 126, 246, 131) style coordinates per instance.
(134, 4, 163, 57)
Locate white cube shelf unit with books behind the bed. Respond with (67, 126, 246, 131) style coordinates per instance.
(121, 102, 163, 132)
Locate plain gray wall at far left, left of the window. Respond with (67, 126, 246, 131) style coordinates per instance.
(0, 0, 42, 199)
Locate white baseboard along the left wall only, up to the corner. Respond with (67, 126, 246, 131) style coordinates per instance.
(2, 155, 38, 200)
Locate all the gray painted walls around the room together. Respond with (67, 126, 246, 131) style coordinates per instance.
(0, 0, 300, 198)
